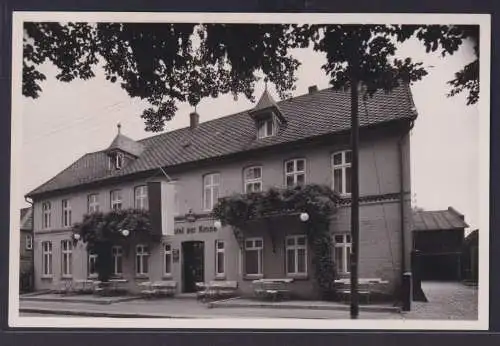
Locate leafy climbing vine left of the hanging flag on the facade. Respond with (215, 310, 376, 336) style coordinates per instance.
(73, 209, 152, 282)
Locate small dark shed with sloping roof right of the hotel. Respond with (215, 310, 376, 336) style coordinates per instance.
(413, 207, 469, 281)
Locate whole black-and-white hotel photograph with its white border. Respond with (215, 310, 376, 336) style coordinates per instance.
(9, 12, 490, 330)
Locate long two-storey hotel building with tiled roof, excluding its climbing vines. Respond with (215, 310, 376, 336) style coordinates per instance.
(27, 86, 416, 298)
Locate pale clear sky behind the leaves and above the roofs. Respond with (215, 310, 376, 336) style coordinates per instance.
(20, 29, 479, 229)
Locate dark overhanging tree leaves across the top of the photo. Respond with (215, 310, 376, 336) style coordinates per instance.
(23, 22, 479, 131)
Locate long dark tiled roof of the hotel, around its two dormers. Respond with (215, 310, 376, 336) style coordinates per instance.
(28, 86, 416, 196)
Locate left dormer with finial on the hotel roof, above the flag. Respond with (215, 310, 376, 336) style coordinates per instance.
(106, 123, 144, 169)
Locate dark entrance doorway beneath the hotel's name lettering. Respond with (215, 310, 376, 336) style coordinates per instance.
(182, 241, 205, 293)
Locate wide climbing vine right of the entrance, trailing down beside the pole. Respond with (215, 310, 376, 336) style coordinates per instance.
(213, 184, 339, 296)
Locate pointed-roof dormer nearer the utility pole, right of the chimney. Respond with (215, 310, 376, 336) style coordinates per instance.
(249, 85, 286, 139)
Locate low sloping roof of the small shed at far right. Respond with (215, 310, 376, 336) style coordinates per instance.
(413, 207, 469, 231)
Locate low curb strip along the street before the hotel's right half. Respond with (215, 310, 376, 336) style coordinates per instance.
(208, 300, 401, 313)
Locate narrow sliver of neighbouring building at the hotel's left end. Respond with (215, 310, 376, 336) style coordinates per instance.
(19, 207, 33, 292)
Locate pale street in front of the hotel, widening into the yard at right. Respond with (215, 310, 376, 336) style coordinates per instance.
(20, 282, 477, 320)
